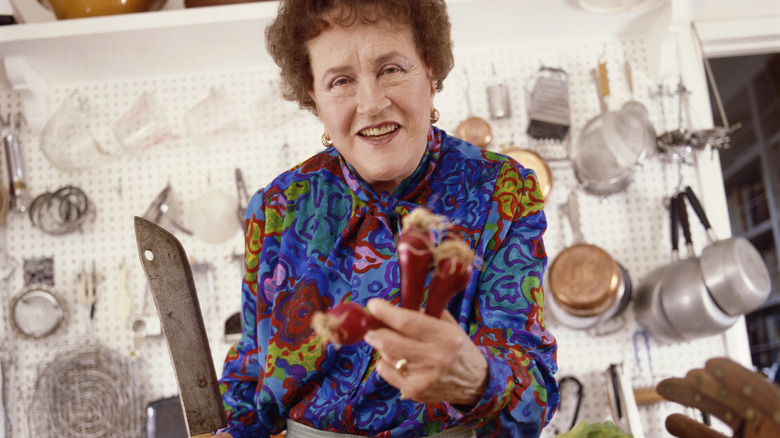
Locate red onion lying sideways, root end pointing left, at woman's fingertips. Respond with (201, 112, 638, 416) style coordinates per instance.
(312, 302, 385, 345)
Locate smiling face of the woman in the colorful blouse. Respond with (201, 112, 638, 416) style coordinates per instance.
(308, 21, 436, 193)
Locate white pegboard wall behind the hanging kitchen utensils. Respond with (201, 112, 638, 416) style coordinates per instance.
(0, 38, 740, 437)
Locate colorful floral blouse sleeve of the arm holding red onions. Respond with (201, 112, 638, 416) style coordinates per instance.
(448, 162, 560, 437)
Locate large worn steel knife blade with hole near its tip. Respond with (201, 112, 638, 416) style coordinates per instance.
(135, 216, 225, 438)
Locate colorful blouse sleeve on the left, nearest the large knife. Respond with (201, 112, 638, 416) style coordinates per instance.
(220, 191, 276, 438)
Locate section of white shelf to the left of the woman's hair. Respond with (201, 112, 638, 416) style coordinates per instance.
(0, 2, 276, 87)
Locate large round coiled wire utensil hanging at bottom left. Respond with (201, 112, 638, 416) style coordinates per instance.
(28, 340, 143, 438)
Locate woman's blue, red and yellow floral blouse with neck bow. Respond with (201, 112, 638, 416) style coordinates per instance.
(221, 127, 560, 438)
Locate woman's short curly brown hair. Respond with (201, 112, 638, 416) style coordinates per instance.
(265, 0, 454, 112)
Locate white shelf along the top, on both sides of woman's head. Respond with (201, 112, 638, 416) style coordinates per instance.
(0, 0, 668, 87)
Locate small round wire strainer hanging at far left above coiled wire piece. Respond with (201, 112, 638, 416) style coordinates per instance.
(11, 285, 66, 339)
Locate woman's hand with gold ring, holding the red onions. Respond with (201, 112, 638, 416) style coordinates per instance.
(364, 299, 488, 405)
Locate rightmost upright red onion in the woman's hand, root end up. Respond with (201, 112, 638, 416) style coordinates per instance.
(425, 240, 474, 318)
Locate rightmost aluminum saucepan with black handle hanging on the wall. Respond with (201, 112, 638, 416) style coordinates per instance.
(685, 187, 772, 315)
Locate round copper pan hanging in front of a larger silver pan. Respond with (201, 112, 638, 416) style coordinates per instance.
(549, 243, 623, 316)
